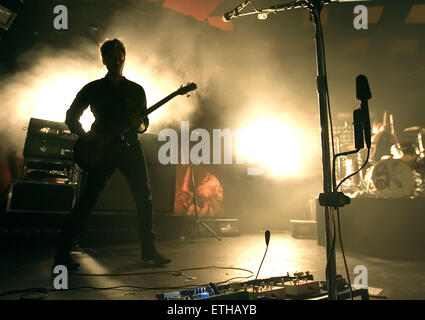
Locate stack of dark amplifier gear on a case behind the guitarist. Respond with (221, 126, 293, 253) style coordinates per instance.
(7, 118, 80, 213)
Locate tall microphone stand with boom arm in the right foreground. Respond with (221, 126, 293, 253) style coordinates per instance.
(224, 0, 338, 300)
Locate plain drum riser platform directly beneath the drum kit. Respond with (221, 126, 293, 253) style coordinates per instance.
(314, 197, 425, 259)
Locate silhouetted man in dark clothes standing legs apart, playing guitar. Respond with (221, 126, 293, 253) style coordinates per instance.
(54, 39, 171, 269)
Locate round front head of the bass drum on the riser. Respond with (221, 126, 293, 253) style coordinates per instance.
(372, 159, 415, 198)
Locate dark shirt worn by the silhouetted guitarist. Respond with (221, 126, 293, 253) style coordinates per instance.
(65, 76, 149, 135)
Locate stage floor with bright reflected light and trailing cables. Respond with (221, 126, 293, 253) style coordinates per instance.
(0, 231, 425, 300)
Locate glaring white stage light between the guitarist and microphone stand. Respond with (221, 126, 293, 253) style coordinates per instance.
(236, 117, 302, 177)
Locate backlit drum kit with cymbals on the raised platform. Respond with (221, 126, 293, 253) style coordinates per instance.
(340, 115, 425, 198)
